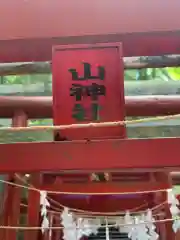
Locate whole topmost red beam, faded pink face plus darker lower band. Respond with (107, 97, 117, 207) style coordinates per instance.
(0, 0, 180, 62)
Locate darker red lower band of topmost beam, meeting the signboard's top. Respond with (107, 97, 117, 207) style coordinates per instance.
(0, 31, 180, 63)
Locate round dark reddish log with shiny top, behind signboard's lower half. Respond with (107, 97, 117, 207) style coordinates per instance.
(0, 95, 180, 118)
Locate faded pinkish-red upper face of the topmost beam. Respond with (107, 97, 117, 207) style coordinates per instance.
(0, 0, 180, 40)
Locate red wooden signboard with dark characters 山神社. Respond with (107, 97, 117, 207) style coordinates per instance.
(52, 44, 125, 140)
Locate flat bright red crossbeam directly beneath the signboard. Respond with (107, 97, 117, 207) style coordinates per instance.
(0, 138, 180, 173)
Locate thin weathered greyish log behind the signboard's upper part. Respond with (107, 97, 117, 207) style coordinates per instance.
(0, 55, 180, 76)
